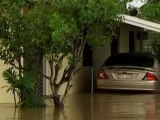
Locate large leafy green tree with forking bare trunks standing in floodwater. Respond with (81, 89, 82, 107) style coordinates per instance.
(0, 0, 123, 106)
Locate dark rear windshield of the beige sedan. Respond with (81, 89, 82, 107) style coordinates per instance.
(104, 55, 154, 67)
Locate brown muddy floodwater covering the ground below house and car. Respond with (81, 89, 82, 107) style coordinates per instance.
(0, 93, 160, 120)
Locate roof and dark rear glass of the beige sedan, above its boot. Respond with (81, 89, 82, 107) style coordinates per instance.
(102, 53, 157, 66)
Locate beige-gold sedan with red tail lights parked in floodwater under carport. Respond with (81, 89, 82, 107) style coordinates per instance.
(96, 53, 160, 91)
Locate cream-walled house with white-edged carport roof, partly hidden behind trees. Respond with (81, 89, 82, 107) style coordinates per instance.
(0, 15, 160, 103)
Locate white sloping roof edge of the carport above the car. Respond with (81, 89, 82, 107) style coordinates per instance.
(123, 15, 160, 32)
